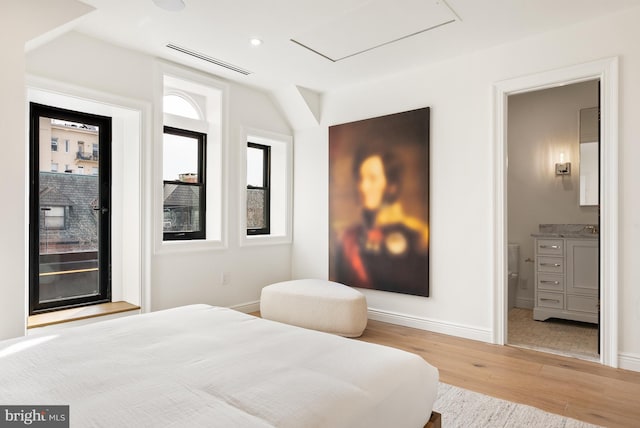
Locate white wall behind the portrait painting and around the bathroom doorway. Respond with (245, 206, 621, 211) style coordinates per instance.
(293, 8, 640, 370)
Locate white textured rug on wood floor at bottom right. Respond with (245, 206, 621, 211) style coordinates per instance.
(433, 382, 595, 428)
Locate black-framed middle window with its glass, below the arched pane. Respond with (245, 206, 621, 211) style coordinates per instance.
(162, 126, 206, 241)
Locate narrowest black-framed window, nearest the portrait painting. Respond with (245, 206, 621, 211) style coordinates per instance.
(247, 143, 271, 235)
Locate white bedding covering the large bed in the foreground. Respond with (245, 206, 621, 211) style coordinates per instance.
(0, 305, 438, 428)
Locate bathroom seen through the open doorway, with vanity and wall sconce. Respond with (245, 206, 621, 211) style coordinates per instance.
(505, 79, 600, 361)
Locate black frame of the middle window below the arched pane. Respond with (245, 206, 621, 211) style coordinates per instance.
(162, 126, 207, 241)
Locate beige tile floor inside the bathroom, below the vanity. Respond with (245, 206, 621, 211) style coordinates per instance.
(507, 308, 600, 361)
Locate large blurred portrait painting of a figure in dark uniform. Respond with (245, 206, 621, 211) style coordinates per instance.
(329, 107, 429, 297)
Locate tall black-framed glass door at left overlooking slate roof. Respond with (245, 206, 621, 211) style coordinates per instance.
(29, 103, 111, 314)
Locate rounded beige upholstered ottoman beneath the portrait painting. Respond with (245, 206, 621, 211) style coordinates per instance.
(260, 279, 367, 337)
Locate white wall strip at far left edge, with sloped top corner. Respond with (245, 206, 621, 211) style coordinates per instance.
(0, 0, 91, 338)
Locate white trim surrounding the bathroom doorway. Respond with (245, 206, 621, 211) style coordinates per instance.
(492, 57, 619, 367)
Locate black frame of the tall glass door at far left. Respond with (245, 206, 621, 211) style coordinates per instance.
(29, 102, 112, 315)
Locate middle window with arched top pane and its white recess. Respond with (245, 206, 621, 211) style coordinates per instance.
(160, 71, 226, 252)
